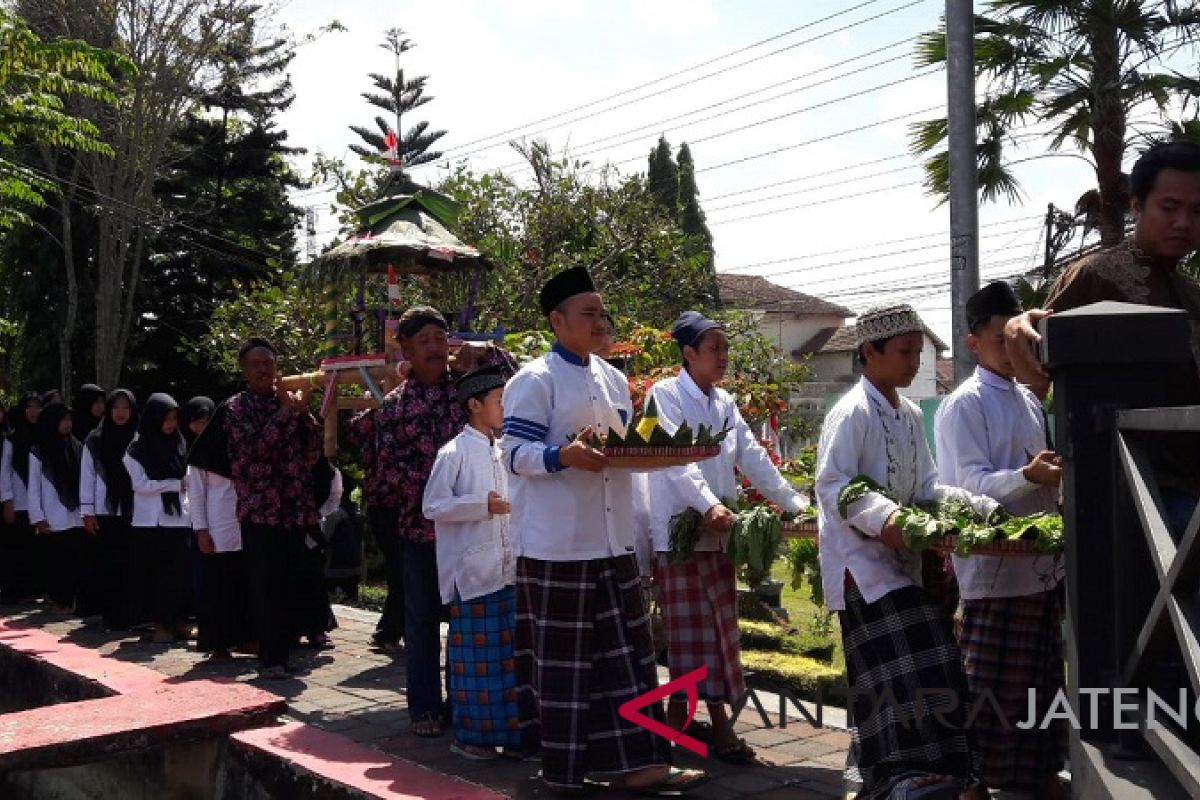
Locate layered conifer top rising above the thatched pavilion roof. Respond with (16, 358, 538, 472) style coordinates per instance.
(350, 28, 446, 167)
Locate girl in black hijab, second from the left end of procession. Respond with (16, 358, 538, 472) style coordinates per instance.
(29, 403, 84, 614)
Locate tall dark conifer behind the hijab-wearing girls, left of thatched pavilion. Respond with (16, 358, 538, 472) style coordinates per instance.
(128, 14, 301, 397)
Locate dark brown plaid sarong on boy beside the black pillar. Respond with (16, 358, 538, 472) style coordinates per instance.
(955, 588, 1067, 792)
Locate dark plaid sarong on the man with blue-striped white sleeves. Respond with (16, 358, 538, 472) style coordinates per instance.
(517, 555, 671, 788)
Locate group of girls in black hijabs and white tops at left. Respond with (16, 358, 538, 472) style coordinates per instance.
(0, 355, 352, 676)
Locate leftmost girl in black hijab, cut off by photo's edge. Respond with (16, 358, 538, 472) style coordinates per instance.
(0, 392, 42, 603)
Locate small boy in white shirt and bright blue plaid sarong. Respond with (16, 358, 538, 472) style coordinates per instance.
(422, 367, 521, 760)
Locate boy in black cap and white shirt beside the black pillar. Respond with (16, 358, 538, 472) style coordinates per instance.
(934, 282, 1067, 798)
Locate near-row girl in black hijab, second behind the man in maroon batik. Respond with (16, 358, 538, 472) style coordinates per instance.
(124, 393, 192, 643)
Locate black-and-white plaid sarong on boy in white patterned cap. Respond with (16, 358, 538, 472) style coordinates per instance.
(838, 584, 978, 800)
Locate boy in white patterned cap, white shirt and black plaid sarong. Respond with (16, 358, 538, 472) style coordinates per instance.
(816, 305, 996, 800)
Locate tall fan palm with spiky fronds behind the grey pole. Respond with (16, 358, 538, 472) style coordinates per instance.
(911, 0, 1200, 245)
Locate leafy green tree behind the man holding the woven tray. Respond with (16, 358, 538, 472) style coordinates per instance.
(441, 143, 715, 330)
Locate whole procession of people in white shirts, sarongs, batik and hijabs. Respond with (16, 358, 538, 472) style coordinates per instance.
(7, 143, 1200, 800)
